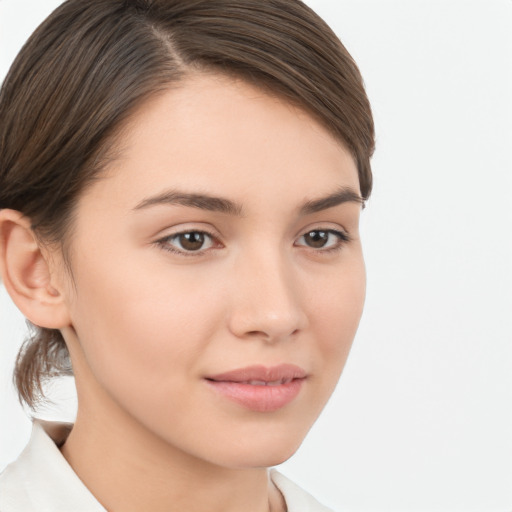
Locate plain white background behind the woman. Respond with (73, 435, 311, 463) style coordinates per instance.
(0, 0, 512, 512)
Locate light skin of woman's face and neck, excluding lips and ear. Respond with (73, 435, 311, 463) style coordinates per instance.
(0, 74, 365, 512)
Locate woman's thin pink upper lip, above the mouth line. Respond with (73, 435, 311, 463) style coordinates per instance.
(206, 364, 307, 383)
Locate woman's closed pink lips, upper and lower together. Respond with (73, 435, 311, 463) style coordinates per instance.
(206, 364, 307, 412)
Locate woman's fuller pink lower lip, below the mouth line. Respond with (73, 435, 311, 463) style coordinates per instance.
(207, 379, 305, 412)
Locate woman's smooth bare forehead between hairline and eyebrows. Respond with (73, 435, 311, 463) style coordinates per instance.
(81, 73, 359, 213)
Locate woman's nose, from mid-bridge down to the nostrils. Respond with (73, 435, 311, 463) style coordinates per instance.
(228, 249, 308, 343)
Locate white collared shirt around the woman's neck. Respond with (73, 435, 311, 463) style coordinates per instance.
(0, 422, 332, 512)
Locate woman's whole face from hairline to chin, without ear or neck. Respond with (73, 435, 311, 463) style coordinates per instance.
(59, 74, 365, 467)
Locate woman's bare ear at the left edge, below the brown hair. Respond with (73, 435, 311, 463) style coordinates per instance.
(0, 209, 70, 329)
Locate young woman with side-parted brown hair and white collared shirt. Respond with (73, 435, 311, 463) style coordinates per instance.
(0, 0, 374, 512)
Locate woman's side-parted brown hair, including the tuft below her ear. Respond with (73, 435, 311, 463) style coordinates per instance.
(0, 0, 374, 407)
